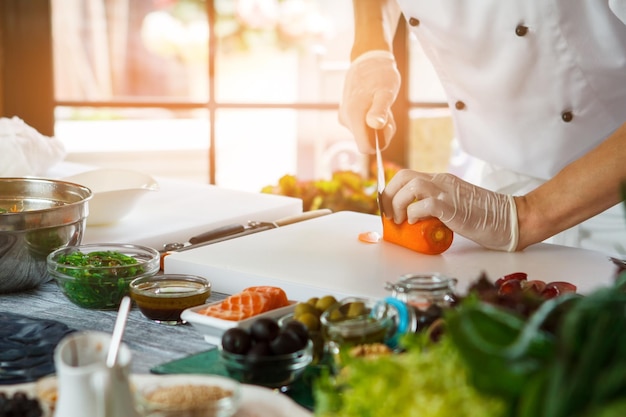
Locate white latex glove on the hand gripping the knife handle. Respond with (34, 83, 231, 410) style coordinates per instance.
(339, 50, 400, 153)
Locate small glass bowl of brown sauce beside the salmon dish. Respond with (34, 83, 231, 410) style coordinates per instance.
(130, 274, 211, 325)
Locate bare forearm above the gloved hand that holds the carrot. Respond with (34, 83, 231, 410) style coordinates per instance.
(515, 124, 626, 250)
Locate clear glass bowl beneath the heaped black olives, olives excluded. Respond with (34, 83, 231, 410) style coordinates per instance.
(218, 340, 313, 391)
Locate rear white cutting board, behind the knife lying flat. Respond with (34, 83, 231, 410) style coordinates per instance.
(83, 178, 302, 250)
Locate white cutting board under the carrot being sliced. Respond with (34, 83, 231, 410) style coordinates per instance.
(165, 212, 615, 301)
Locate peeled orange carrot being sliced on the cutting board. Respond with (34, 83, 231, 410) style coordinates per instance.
(383, 216, 454, 255)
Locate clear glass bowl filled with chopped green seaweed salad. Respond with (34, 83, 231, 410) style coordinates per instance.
(47, 243, 160, 310)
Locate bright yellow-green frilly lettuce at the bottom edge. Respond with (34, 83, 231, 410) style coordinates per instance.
(314, 335, 507, 417)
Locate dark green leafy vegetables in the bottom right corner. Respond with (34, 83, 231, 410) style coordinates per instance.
(446, 275, 626, 417)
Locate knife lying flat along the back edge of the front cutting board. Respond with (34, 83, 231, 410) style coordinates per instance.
(162, 209, 332, 252)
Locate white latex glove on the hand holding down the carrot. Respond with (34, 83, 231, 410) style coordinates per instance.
(383, 170, 518, 252)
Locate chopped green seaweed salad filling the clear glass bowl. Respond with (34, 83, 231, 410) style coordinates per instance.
(56, 251, 144, 308)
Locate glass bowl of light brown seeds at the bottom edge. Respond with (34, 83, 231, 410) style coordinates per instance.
(136, 375, 241, 417)
